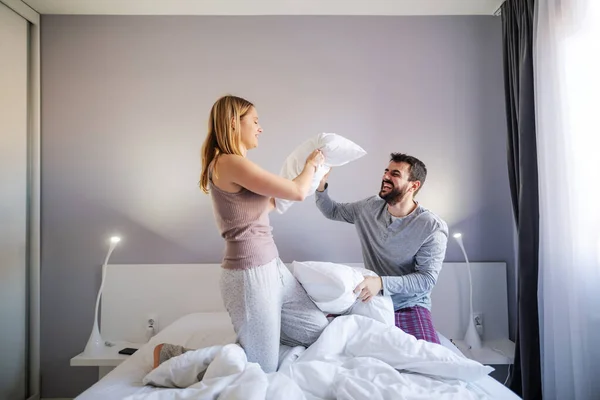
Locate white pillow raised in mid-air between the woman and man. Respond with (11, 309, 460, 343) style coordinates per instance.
(275, 133, 367, 214)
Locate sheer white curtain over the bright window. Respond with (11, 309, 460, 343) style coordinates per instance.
(533, 0, 600, 400)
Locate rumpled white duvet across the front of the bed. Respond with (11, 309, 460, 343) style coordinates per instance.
(126, 315, 493, 400)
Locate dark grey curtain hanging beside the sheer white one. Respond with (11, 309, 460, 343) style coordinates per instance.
(501, 0, 542, 400)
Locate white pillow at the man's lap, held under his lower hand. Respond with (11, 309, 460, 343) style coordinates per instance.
(290, 261, 395, 325)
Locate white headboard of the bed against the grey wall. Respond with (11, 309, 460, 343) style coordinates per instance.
(101, 262, 508, 343)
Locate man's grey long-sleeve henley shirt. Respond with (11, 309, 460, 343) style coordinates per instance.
(315, 189, 448, 310)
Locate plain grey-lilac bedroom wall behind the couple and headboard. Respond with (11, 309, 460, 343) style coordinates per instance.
(41, 16, 515, 397)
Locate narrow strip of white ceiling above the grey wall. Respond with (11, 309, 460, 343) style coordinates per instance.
(21, 0, 504, 15)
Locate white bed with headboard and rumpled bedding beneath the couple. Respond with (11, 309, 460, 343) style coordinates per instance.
(76, 263, 519, 400)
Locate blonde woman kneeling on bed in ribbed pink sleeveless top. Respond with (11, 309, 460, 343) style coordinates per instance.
(155, 96, 328, 373)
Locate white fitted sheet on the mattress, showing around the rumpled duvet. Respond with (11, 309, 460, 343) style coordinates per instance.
(77, 313, 519, 400)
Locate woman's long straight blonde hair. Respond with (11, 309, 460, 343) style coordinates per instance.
(200, 96, 254, 193)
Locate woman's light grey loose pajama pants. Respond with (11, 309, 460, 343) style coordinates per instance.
(221, 258, 328, 373)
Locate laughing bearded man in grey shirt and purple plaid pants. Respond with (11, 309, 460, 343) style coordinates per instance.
(316, 153, 448, 343)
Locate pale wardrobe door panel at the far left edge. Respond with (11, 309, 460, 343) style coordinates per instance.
(0, 3, 28, 400)
